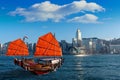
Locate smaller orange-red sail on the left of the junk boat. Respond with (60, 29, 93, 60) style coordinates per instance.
(6, 39, 29, 56)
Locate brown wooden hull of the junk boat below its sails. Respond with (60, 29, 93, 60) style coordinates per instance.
(14, 59, 62, 75)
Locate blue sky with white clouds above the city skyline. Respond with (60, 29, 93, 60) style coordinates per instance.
(0, 0, 120, 43)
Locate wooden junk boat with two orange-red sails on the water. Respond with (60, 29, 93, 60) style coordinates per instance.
(6, 32, 63, 74)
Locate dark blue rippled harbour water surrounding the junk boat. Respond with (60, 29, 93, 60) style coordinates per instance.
(0, 55, 120, 80)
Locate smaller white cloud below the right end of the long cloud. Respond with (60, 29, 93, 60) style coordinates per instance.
(68, 14, 100, 23)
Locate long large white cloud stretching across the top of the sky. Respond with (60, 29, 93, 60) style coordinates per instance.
(9, 0, 105, 22)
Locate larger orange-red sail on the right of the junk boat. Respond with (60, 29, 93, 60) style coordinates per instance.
(34, 32, 62, 56)
